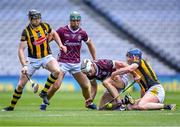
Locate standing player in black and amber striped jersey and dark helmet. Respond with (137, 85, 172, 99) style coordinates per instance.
(3, 10, 67, 111)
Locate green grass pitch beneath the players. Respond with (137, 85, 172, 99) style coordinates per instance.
(0, 92, 180, 127)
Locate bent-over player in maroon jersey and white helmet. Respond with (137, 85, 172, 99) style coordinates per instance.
(81, 59, 137, 109)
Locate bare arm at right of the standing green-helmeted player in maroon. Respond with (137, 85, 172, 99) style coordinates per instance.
(86, 38, 96, 60)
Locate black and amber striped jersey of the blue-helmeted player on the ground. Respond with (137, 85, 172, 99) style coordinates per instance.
(133, 59, 159, 92)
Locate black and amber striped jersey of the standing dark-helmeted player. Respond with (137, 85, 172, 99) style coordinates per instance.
(21, 23, 52, 59)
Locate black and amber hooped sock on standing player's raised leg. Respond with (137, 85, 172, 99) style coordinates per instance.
(42, 74, 57, 93)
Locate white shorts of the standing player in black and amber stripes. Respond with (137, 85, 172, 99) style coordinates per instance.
(28, 55, 56, 76)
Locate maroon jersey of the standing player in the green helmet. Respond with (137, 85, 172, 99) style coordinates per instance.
(57, 25, 88, 63)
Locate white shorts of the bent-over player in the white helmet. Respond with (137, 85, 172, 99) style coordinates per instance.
(121, 73, 134, 87)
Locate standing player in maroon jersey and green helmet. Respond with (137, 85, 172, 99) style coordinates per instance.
(40, 11, 96, 110)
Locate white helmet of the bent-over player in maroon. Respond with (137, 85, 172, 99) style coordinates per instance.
(81, 59, 93, 73)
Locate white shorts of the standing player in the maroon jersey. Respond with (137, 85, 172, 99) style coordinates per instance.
(59, 62, 81, 74)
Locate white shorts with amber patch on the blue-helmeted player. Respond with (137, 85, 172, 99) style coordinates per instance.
(146, 84, 165, 103)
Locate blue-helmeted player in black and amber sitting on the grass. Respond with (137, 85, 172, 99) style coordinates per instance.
(111, 49, 176, 110)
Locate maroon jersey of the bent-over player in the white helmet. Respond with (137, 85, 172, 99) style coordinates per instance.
(88, 59, 115, 81)
